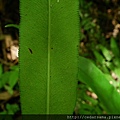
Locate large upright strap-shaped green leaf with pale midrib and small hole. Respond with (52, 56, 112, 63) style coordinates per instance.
(20, 0, 79, 114)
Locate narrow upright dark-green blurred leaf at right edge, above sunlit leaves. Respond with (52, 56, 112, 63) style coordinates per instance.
(110, 37, 120, 57)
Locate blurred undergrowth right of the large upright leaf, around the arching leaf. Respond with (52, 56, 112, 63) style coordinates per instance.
(76, 0, 120, 114)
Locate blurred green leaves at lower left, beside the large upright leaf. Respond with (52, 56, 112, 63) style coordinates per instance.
(0, 65, 19, 116)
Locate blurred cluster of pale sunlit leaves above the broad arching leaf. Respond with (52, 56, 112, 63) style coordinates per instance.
(94, 38, 120, 90)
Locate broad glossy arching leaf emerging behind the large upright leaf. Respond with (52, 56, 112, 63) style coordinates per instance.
(78, 57, 120, 114)
